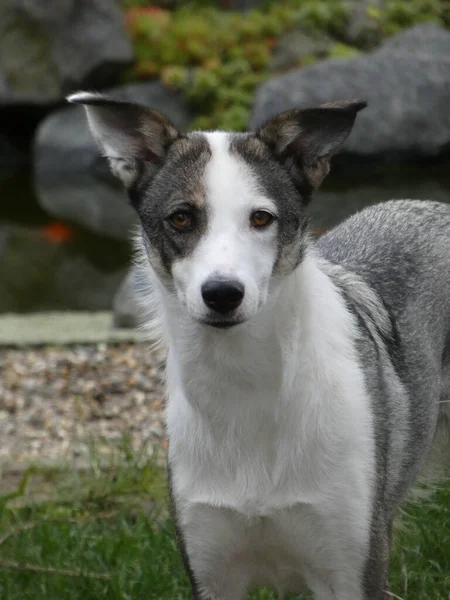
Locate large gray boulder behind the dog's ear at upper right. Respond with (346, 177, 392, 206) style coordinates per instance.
(251, 23, 450, 157)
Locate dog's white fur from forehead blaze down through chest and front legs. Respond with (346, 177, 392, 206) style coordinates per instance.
(132, 134, 375, 600)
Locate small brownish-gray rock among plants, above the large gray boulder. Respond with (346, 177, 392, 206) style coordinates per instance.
(270, 29, 333, 71)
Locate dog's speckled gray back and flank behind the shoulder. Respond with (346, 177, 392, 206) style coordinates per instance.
(317, 200, 450, 502)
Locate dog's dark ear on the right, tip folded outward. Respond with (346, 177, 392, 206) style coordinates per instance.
(256, 100, 367, 193)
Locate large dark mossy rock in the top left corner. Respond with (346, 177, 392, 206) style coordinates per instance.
(0, 0, 133, 104)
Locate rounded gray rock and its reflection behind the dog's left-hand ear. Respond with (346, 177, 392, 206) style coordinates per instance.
(34, 82, 190, 240)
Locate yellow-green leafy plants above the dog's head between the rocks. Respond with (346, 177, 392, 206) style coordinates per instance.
(123, 0, 352, 130)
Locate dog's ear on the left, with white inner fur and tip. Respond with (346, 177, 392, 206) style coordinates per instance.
(67, 92, 182, 188)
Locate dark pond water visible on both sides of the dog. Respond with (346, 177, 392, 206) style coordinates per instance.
(0, 160, 450, 313)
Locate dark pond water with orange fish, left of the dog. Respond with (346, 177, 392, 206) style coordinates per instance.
(0, 165, 131, 313)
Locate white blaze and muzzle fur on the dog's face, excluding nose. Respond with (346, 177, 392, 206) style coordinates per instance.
(172, 132, 277, 326)
